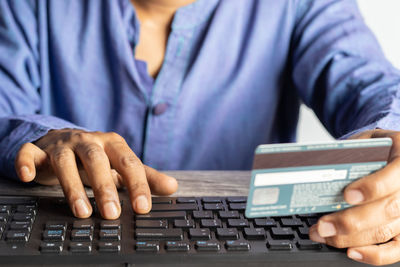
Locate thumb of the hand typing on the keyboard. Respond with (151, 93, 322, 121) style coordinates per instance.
(144, 165, 178, 195)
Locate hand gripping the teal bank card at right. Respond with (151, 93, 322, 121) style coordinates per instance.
(310, 130, 400, 265)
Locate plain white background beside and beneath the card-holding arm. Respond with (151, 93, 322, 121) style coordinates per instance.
(297, 0, 400, 142)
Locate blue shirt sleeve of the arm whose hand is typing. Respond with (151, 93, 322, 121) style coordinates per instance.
(0, 0, 83, 181)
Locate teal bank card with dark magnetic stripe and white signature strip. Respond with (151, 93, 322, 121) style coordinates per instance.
(246, 138, 392, 218)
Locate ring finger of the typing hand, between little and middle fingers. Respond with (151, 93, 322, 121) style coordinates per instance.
(49, 147, 92, 218)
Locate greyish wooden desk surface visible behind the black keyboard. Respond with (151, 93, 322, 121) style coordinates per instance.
(0, 171, 250, 197)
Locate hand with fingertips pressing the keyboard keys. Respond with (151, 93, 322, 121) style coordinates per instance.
(15, 129, 178, 219)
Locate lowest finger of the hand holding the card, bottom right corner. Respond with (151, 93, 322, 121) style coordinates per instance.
(347, 236, 400, 265)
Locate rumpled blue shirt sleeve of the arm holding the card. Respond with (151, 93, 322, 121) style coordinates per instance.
(291, 0, 400, 138)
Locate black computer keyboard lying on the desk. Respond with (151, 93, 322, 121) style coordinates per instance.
(0, 196, 376, 267)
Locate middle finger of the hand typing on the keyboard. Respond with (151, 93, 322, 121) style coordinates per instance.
(75, 143, 121, 220)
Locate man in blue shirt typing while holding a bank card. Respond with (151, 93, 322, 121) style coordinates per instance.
(0, 0, 400, 264)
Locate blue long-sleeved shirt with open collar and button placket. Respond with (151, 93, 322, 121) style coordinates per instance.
(0, 0, 400, 180)
